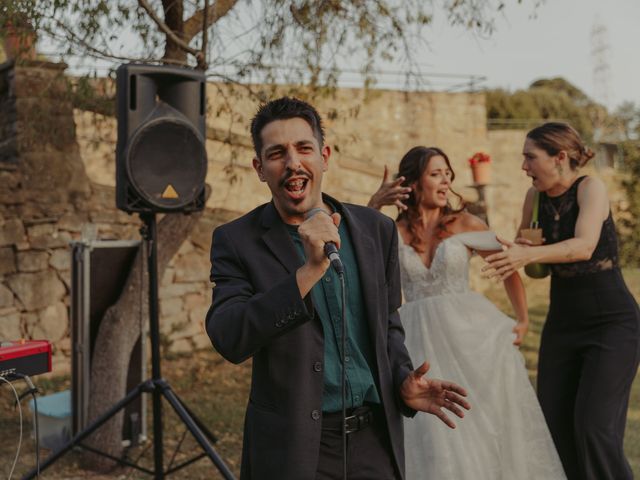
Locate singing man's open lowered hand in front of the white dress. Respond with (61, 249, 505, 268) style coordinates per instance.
(400, 362, 471, 428)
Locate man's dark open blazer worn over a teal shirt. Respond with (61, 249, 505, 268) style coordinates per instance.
(207, 196, 415, 480)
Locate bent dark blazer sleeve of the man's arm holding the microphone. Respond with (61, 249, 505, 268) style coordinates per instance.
(206, 228, 313, 363)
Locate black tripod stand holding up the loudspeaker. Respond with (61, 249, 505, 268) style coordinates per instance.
(23, 213, 235, 480)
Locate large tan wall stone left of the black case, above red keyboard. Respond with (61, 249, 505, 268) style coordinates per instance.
(6, 270, 67, 311)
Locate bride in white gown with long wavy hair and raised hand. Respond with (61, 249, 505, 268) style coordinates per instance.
(369, 147, 566, 480)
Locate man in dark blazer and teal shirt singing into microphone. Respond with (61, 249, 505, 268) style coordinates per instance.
(207, 97, 469, 480)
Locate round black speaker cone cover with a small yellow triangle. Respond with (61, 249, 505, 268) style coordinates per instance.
(126, 117, 207, 210)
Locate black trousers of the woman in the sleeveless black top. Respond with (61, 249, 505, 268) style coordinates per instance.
(538, 269, 640, 480)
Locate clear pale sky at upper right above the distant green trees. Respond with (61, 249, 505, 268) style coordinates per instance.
(418, 0, 640, 108)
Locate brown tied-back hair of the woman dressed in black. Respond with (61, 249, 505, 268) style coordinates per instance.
(527, 122, 595, 170)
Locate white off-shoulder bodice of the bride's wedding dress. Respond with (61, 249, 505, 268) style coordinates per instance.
(399, 231, 501, 302)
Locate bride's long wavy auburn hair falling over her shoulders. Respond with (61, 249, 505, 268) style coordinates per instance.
(396, 146, 464, 253)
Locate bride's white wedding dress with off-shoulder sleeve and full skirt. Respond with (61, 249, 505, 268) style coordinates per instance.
(399, 231, 566, 480)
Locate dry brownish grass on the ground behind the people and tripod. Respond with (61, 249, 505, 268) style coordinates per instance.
(0, 269, 640, 480)
